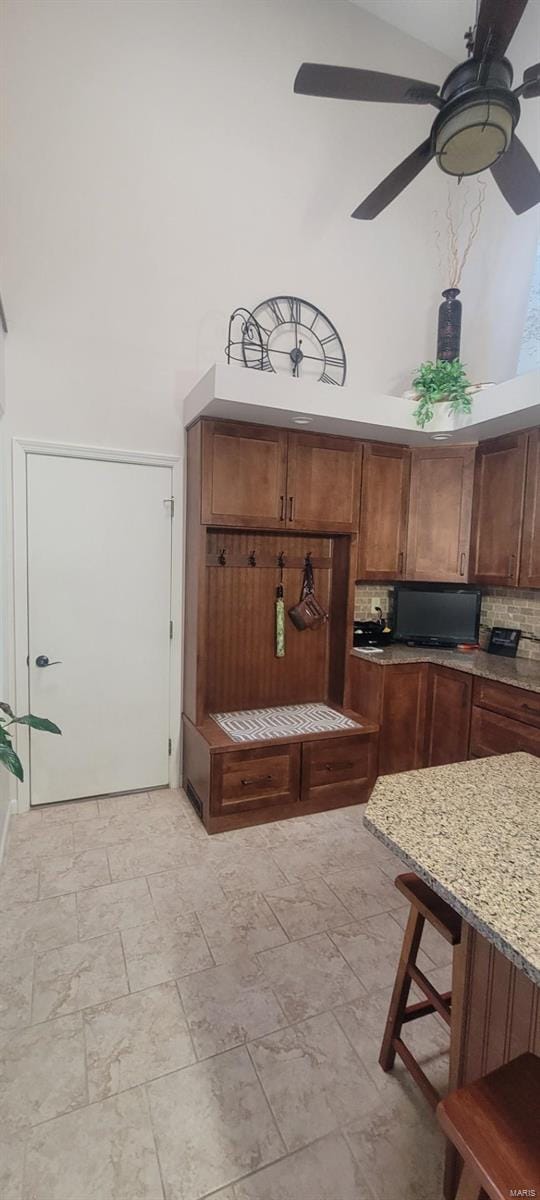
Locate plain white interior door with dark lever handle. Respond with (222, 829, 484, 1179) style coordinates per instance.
(26, 454, 172, 804)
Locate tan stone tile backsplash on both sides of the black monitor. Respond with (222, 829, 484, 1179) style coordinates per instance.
(354, 583, 540, 660)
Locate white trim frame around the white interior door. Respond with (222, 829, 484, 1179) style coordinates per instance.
(12, 438, 184, 812)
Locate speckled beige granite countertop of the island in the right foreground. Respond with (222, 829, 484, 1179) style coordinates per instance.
(364, 754, 540, 984)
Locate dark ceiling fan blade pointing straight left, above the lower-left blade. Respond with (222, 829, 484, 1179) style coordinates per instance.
(294, 62, 440, 108)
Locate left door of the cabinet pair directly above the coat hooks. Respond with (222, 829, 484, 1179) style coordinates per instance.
(202, 421, 287, 529)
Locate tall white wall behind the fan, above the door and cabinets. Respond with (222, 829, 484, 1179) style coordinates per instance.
(0, 0, 538, 451)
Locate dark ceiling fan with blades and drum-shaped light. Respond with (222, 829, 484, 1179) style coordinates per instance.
(294, 0, 540, 221)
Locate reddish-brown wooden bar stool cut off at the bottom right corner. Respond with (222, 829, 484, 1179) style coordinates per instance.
(437, 1054, 540, 1200)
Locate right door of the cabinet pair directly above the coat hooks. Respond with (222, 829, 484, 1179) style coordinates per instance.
(287, 433, 362, 533)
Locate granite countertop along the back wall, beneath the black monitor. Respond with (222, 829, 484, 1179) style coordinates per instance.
(350, 643, 540, 691)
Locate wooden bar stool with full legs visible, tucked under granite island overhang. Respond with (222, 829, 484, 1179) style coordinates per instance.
(379, 872, 461, 1109)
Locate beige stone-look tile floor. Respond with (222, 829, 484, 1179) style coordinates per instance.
(0, 791, 449, 1200)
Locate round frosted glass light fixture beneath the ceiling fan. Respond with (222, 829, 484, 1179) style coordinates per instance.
(434, 97, 516, 175)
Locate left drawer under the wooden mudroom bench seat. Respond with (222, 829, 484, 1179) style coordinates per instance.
(211, 743, 300, 814)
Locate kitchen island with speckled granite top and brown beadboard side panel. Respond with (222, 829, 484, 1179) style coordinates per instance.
(365, 754, 540, 1200)
